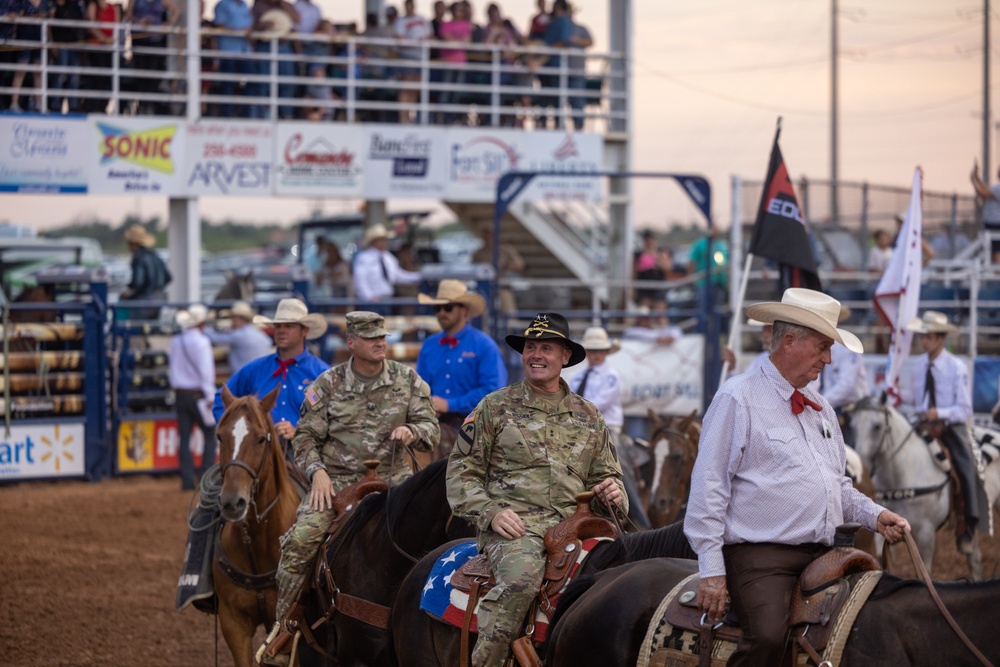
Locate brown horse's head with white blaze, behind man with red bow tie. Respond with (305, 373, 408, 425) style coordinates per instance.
(643, 410, 701, 528)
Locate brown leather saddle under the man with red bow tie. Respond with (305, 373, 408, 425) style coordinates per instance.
(664, 524, 880, 665)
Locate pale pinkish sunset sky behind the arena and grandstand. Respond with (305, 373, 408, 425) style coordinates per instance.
(0, 0, 1000, 234)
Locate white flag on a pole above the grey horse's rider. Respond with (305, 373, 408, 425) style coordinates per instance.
(874, 167, 924, 405)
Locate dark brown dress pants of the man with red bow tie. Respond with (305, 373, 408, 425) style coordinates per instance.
(722, 542, 829, 667)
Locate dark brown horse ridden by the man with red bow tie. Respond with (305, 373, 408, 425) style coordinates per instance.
(545, 559, 1000, 667)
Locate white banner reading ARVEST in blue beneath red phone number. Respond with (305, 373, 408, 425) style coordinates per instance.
(184, 121, 274, 197)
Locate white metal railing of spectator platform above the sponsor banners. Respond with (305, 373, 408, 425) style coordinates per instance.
(0, 18, 627, 131)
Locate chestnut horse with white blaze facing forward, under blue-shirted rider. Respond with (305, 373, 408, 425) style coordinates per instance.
(212, 386, 299, 667)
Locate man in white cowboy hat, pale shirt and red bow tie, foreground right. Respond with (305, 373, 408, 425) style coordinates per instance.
(684, 288, 909, 667)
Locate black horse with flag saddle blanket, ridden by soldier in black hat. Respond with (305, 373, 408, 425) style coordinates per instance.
(392, 523, 695, 667)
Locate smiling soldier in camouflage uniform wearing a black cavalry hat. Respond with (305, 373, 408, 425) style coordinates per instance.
(447, 313, 628, 667)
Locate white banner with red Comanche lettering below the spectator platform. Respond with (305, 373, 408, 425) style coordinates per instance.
(274, 123, 368, 197)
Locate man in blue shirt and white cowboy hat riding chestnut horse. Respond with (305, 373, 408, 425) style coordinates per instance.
(212, 299, 330, 448)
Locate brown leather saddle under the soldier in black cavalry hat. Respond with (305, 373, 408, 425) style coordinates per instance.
(451, 491, 620, 609)
